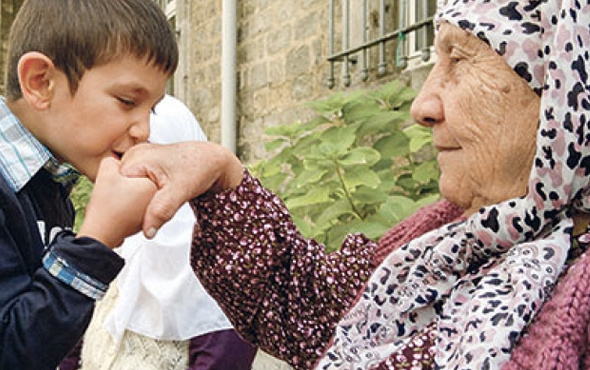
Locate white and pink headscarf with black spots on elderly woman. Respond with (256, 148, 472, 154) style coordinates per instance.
(318, 0, 590, 369)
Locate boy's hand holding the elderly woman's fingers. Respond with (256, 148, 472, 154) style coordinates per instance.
(78, 158, 156, 248)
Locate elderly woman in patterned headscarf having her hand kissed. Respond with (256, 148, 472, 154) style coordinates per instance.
(123, 0, 590, 369)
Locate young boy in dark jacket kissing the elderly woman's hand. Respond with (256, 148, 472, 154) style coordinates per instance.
(0, 0, 178, 369)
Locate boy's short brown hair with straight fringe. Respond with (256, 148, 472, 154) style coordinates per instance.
(6, 0, 178, 100)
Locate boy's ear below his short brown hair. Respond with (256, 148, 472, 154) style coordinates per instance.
(18, 51, 55, 110)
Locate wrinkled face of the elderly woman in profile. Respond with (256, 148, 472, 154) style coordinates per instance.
(412, 23, 540, 214)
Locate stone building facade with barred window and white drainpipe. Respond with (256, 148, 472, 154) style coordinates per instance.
(0, 0, 436, 162)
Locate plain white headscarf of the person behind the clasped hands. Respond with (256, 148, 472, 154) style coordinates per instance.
(104, 96, 232, 344)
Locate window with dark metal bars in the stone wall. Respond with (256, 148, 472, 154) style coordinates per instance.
(328, 0, 440, 88)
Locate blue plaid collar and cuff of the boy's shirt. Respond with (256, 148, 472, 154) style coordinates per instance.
(0, 97, 108, 299)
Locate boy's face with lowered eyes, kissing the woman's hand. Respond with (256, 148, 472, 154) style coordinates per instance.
(38, 56, 168, 181)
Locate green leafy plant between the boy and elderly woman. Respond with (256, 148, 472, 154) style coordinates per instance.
(249, 81, 439, 250)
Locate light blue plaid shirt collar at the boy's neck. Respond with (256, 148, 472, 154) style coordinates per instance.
(0, 96, 79, 192)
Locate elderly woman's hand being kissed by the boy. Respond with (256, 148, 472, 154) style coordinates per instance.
(121, 141, 243, 238)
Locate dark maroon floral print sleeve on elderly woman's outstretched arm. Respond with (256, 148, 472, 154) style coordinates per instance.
(191, 171, 375, 369)
